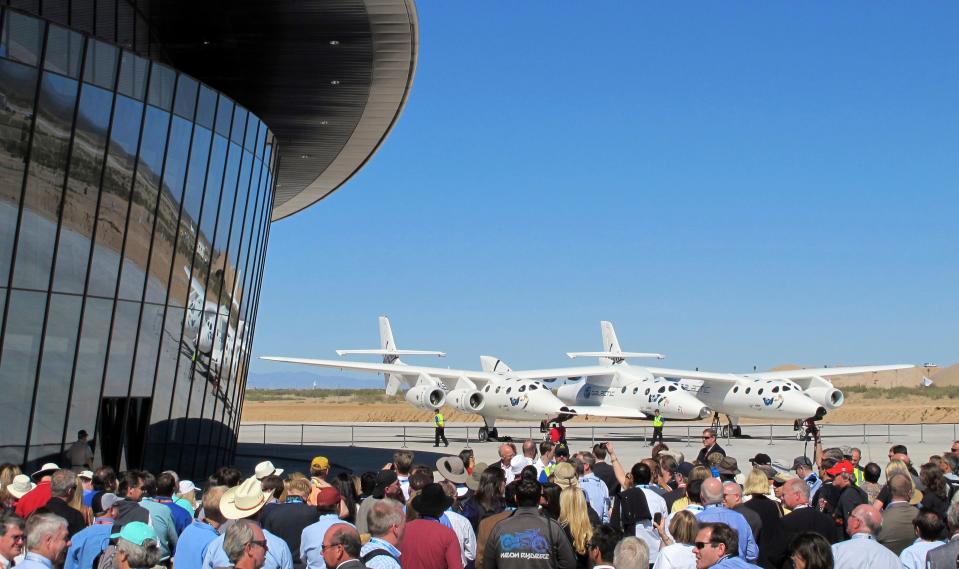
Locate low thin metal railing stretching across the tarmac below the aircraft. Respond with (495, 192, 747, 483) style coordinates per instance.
(239, 423, 957, 448)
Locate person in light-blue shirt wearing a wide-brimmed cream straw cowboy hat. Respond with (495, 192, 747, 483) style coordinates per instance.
(201, 476, 293, 569)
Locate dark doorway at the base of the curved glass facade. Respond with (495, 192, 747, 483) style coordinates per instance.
(97, 397, 152, 471)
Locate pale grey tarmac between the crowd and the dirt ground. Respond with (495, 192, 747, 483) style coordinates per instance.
(237, 423, 959, 473)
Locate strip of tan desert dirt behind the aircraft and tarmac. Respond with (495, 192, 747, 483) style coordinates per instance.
(243, 393, 959, 424)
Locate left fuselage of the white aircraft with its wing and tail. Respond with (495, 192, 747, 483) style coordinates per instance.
(260, 316, 584, 441)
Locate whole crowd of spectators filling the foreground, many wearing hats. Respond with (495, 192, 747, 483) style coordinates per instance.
(0, 429, 959, 569)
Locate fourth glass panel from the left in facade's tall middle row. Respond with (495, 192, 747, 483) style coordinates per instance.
(88, 95, 143, 297)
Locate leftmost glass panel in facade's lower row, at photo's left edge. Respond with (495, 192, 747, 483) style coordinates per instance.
(0, 290, 47, 452)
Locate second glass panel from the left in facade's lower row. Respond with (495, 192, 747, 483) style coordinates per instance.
(28, 294, 82, 459)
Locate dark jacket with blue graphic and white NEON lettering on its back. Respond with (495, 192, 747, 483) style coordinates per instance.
(483, 507, 576, 569)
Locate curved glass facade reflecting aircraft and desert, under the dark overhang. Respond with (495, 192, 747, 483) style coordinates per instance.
(0, 9, 276, 476)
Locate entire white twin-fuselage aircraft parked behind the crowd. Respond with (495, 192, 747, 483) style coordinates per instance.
(261, 316, 913, 440)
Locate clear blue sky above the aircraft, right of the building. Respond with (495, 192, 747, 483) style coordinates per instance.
(252, 4, 959, 378)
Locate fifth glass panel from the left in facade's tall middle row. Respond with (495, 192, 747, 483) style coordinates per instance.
(120, 106, 170, 302)
